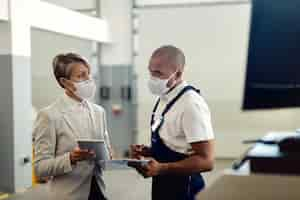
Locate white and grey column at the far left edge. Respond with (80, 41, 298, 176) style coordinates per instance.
(0, 0, 32, 192)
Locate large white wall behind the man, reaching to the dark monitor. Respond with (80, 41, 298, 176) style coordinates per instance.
(135, 4, 298, 157)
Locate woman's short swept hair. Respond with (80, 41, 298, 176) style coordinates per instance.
(52, 53, 90, 88)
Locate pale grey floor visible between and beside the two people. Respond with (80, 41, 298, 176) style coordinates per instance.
(5, 160, 232, 200)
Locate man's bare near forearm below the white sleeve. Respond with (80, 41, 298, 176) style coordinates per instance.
(161, 155, 213, 175)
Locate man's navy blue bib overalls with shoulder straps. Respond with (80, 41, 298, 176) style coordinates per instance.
(151, 86, 205, 200)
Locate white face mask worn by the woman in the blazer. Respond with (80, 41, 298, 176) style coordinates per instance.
(74, 79, 96, 100)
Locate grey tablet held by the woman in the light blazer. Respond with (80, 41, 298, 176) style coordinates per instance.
(77, 139, 109, 160)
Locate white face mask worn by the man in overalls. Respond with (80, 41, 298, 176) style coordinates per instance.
(148, 72, 176, 96)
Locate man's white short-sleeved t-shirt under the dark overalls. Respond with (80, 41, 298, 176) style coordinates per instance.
(154, 81, 214, 154)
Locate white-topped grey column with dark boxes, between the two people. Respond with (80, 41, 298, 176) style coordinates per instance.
(98, 0, 137, 155)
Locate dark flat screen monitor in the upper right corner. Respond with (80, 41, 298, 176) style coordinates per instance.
(243, 0, 300, 110)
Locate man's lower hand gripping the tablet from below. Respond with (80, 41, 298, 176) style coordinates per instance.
(128, 159, 167, 178)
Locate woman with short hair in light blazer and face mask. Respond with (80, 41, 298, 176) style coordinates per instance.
(33, 53, 110, 200)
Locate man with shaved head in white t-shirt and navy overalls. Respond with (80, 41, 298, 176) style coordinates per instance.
(131, 46, 214, 200)
